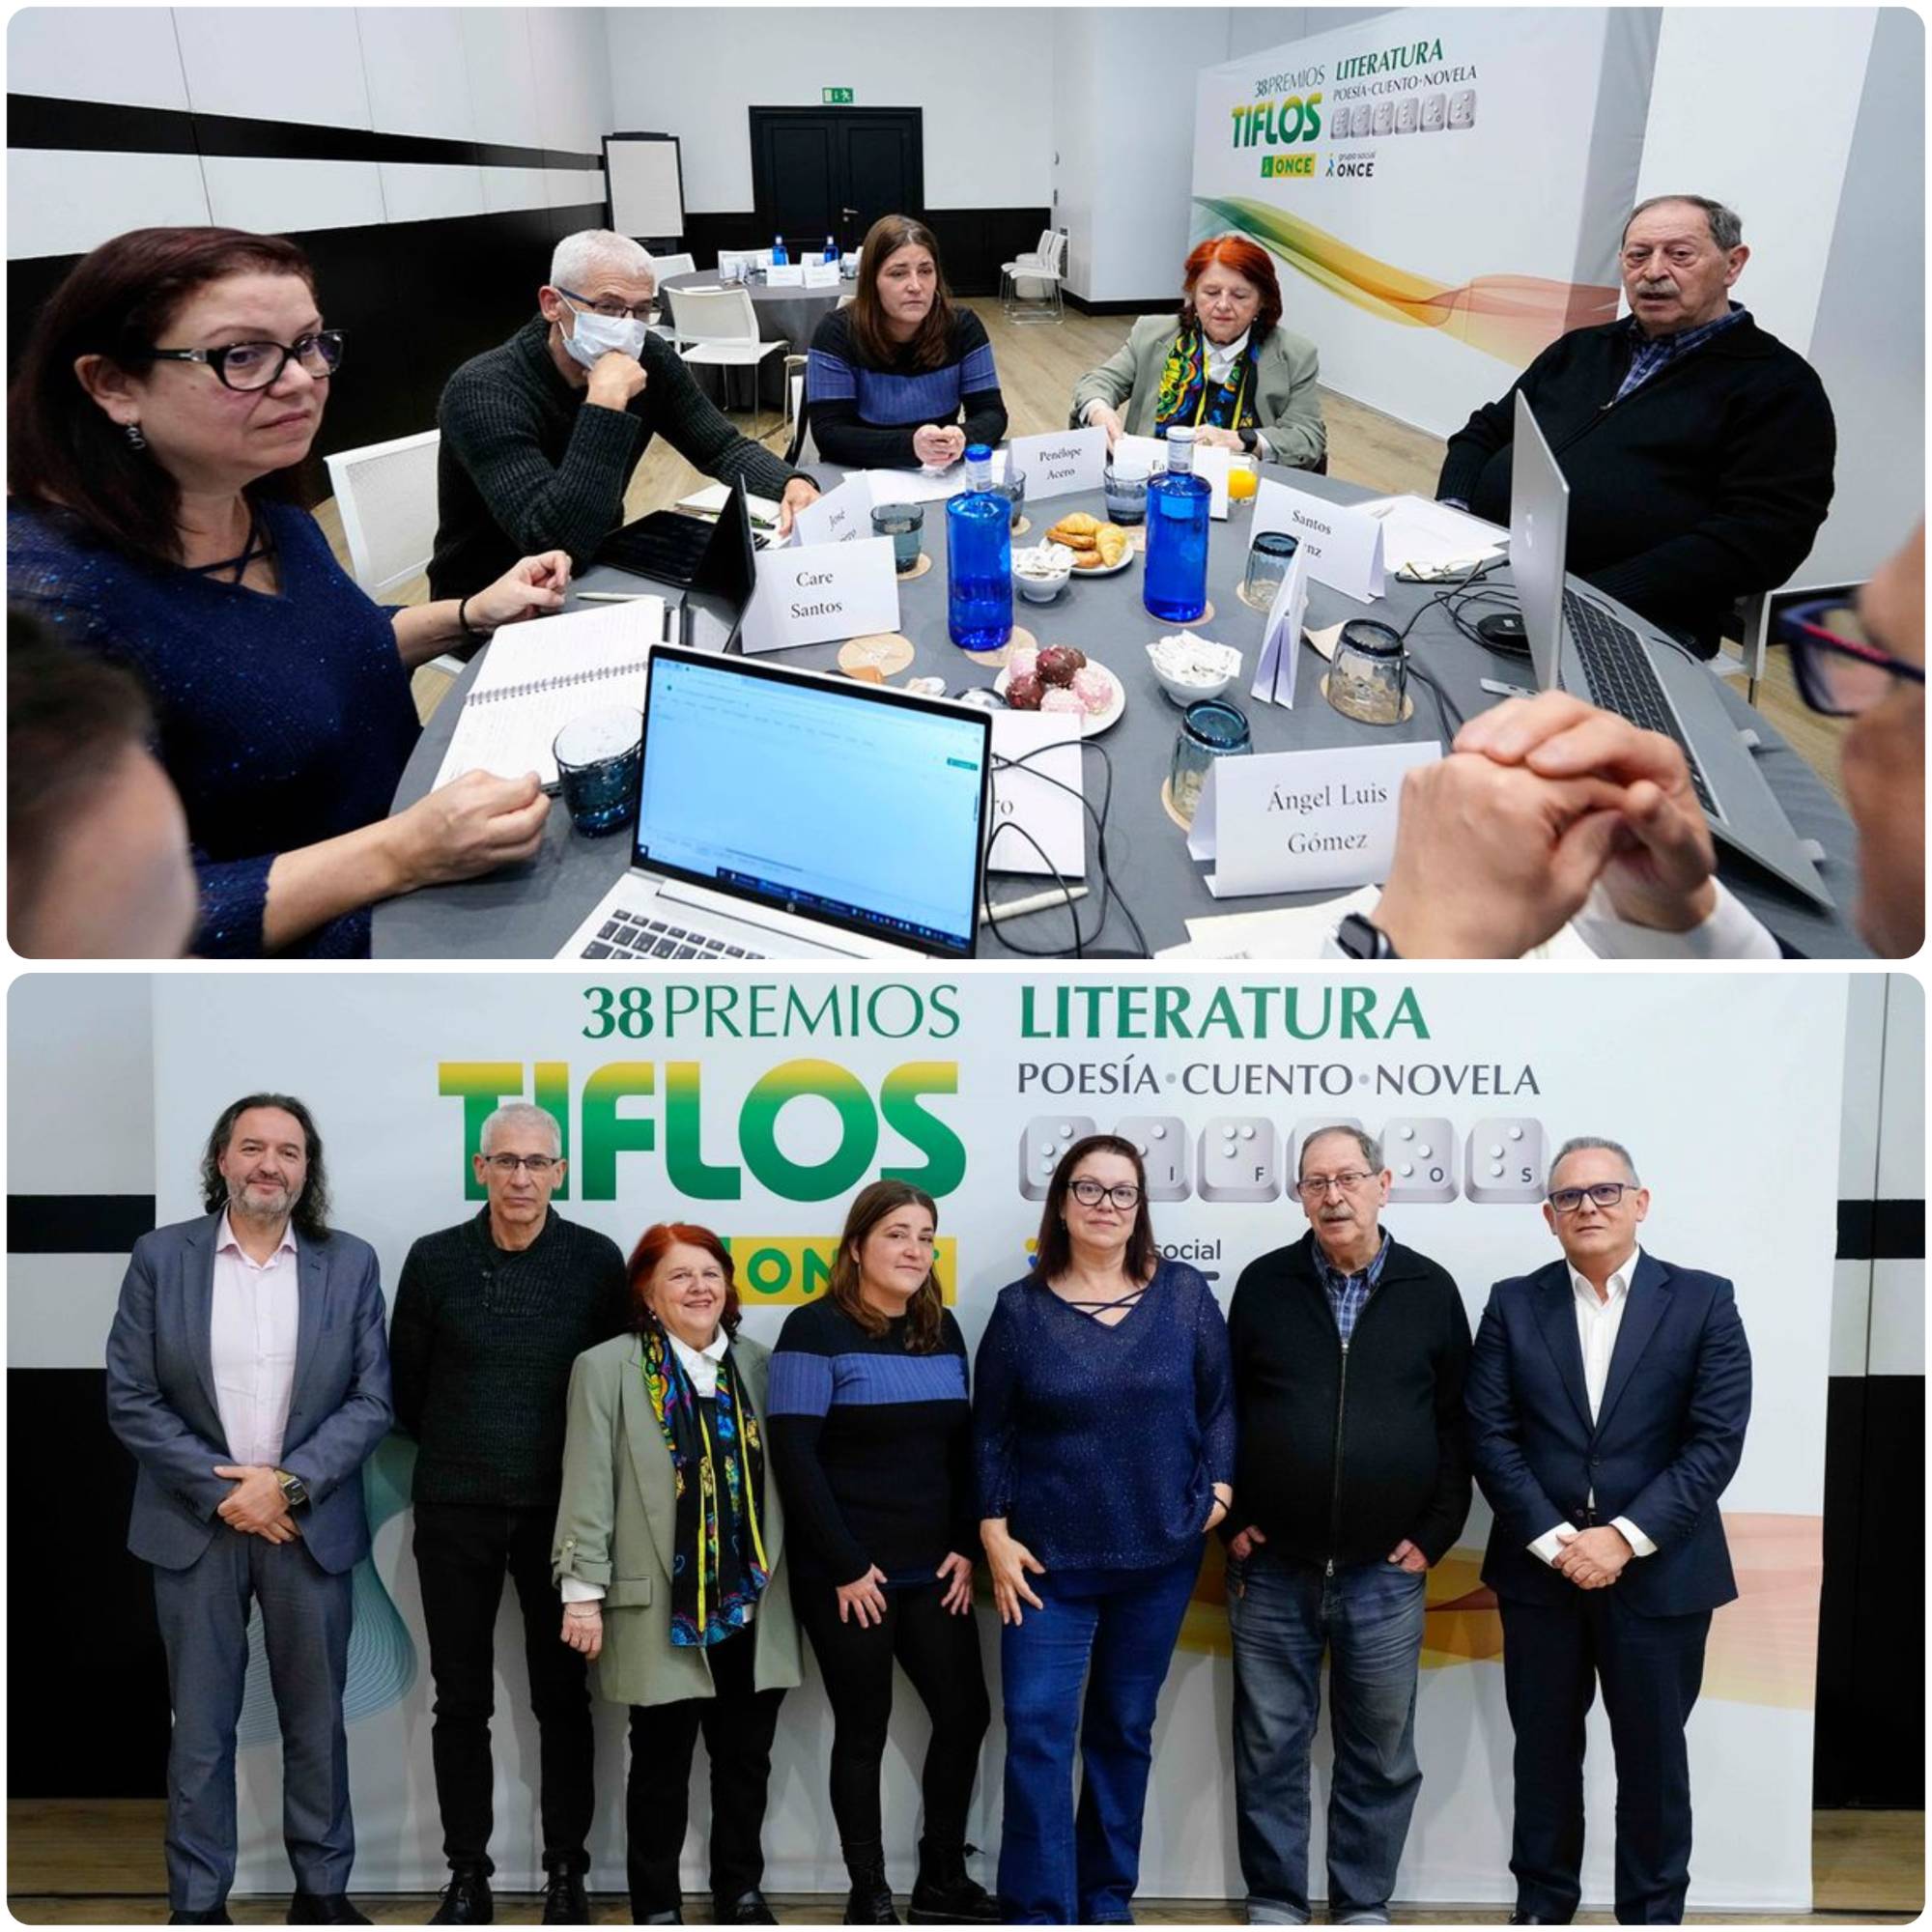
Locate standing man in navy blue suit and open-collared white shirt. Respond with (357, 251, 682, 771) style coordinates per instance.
(1466, 1138, 1750, 1924)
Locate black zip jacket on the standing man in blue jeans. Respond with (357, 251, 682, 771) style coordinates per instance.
(1225, 1231, 1470, 1567)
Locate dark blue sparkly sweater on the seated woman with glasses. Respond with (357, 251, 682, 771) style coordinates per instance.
(6, 502, 421, 958)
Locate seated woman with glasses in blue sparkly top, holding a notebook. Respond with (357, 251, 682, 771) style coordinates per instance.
(8, 228, 570, 958)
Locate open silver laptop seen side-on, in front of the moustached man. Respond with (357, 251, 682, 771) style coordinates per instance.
(1509, 390, 1832, 906)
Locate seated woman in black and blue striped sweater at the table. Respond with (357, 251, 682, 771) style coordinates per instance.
(806, 214, 1007, 469)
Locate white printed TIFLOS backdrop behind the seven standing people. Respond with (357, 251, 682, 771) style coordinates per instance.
(71, 974, 1847, 1909)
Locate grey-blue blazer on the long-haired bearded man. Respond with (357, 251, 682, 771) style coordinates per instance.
(108, 1213, 392, 1573)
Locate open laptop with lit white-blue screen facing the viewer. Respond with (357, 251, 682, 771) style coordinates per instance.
(556, 645, 993, 960)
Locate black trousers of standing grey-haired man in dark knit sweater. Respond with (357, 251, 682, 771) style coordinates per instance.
(415, 1503, 597, 1872)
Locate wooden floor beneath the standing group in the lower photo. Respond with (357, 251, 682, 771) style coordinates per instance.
(8, 1799, 1924, 1926)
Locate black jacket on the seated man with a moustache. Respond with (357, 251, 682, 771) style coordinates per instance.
(1435, 315, 1837, 657)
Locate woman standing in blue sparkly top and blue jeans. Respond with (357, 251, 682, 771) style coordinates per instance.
(974, 1134, 1235, 1924)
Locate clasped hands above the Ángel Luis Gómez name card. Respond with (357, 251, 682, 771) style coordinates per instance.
(1374, 692, 1718, 958)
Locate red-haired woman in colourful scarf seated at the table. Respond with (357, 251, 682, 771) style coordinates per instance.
(1072, 236, 1327, 469)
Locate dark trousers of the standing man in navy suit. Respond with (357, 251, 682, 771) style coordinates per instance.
(1499, 1592, 1710, 1924)
